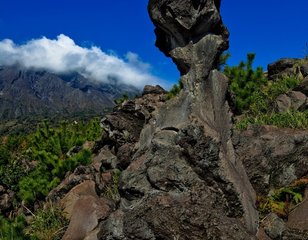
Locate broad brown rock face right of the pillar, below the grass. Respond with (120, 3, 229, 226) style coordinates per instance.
(233, 126, 308, 195)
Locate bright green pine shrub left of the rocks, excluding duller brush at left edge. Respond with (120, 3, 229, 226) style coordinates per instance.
(19, 120, 101, 203)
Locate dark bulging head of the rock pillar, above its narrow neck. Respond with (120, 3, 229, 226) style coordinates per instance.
(148, 0, 229, 86)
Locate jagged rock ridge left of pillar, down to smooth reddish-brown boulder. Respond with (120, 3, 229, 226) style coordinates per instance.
(48, 86, 166, 240)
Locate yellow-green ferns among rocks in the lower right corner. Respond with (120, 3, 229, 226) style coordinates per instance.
(257, 178, 308, 218)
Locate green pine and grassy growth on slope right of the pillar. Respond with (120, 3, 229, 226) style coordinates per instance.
(224, 54, 308, 129)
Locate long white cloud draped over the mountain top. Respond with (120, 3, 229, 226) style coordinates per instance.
(0, 34, 164, 87)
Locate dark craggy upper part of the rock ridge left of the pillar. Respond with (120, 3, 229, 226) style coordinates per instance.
(95, 86, 166, 170)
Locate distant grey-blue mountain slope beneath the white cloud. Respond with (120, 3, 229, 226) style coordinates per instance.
(0, 66, 139, 120)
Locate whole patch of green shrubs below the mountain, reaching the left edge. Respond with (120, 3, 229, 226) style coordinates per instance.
(0, 119, 102, 203)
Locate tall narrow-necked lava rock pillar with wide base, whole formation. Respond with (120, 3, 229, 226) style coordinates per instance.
(98, 0, 258, 240)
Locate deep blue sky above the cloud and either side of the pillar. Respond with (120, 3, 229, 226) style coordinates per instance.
(0, 0, 308, 86)
